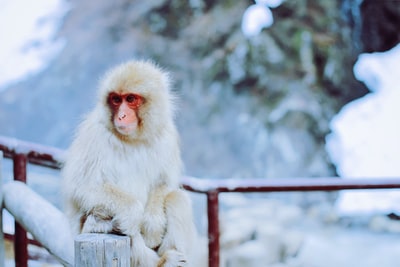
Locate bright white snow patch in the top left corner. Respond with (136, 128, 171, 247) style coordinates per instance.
(0, 0, 68, 90)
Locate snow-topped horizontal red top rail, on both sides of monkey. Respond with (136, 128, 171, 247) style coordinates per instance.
(0, 136, 400, 193)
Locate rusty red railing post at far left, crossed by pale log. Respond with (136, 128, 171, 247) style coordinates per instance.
(13, 154, 28, 267)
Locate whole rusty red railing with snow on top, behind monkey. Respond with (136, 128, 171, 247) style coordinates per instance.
(0, 136, 400, 267)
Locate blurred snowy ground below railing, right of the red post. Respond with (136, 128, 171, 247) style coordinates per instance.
(220, 194, 400, 267)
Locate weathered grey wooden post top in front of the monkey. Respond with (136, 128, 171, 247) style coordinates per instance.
(75, 234, 131, 267)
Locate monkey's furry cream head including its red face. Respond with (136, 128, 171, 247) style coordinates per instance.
(98, 61, 174, 142)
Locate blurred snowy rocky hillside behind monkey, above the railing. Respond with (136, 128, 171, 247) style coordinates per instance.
(0, 0, 400, 266)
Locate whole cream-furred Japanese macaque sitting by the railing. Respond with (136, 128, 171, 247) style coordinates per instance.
(62, 61, 195, 267)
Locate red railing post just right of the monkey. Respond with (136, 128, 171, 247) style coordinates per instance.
(207, 191, 219, 267)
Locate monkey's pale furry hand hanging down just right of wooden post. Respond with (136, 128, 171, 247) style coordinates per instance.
(141, 208, 167, 249)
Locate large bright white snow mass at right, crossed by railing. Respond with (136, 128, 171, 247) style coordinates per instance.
(327, 44, 400, 215)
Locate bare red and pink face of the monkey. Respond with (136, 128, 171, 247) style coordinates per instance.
(107, 92, 144, 135)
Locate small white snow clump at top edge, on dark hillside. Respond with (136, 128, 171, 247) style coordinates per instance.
(242, 0, 283, 38)
